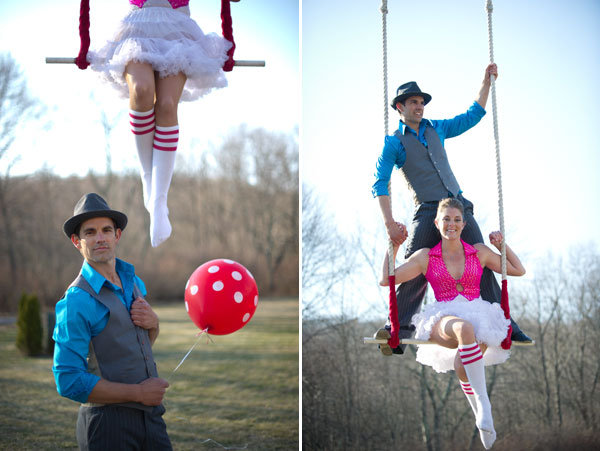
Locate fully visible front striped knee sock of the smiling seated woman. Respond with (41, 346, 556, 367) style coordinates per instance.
(458, 343, 496, 449)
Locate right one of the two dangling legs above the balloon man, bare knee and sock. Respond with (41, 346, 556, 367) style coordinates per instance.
(149, 74, 186, 247)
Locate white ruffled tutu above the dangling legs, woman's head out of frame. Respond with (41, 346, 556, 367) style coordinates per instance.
(88, 0, 231, 101)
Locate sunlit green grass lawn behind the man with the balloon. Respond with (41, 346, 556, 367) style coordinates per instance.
(0, 299, 299, 450)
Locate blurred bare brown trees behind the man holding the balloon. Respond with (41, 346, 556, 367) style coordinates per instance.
(0, 127, 299, 311)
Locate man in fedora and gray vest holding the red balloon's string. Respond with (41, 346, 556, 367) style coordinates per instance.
(52, 193, 172, 450)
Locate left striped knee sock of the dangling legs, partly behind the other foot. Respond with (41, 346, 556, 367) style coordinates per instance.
(129, 108, 154, 208)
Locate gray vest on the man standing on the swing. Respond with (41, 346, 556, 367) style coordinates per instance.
(394, 127, 460, 204)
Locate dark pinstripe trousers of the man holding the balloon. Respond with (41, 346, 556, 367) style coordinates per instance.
(77, 404, 173, 451)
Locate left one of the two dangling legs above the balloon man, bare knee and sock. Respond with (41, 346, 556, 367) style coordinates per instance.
(125, 62, 155, 209)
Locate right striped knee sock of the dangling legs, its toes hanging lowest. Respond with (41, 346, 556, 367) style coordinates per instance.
(150, 125, 179, 247)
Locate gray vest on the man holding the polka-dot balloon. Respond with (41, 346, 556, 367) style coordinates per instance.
(71, 274, 158, 412)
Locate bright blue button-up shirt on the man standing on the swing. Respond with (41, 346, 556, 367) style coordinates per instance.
(372, 102, 485, 197)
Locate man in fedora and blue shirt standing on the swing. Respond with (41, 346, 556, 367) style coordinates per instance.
(372, 63, 532, 356)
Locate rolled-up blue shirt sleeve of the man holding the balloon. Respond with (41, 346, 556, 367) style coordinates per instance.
(52, 288, 100, 402)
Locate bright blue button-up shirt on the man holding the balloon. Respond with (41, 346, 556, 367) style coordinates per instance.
(52, 259, 146, 402)
